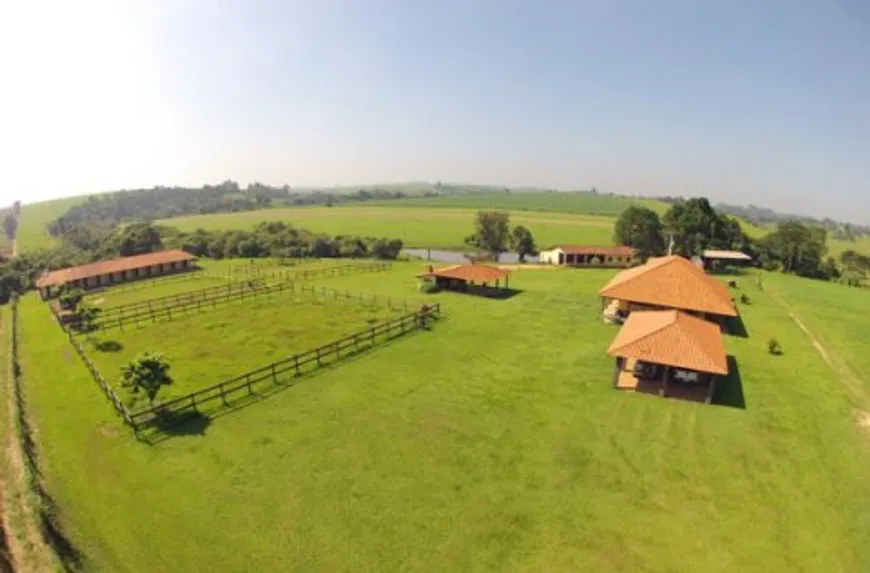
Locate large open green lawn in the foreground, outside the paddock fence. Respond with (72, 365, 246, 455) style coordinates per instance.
(13, 263, 870, 572)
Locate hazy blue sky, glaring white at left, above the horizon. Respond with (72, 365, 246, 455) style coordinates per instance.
(0, 0, 870, 223)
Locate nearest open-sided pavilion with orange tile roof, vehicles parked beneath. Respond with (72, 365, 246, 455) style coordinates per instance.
(607, 310, 728, 404)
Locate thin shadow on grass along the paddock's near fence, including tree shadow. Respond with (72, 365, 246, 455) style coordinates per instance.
(136, 317, 447, 446)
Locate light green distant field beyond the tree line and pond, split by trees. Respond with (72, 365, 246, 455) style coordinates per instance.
(161, 206, 615, 249)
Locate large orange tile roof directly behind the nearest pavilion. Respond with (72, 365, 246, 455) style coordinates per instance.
(599, 255, 737, 316)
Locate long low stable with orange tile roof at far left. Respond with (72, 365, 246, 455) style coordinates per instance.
(36, 250, 196, 299)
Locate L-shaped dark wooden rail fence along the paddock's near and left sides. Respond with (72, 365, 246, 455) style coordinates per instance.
(68, 303, 441, 432)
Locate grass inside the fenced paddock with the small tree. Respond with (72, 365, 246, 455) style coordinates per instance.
(85, 291, 401, 406)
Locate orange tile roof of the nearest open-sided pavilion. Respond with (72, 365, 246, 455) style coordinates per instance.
(607, 310, 728, 376)
